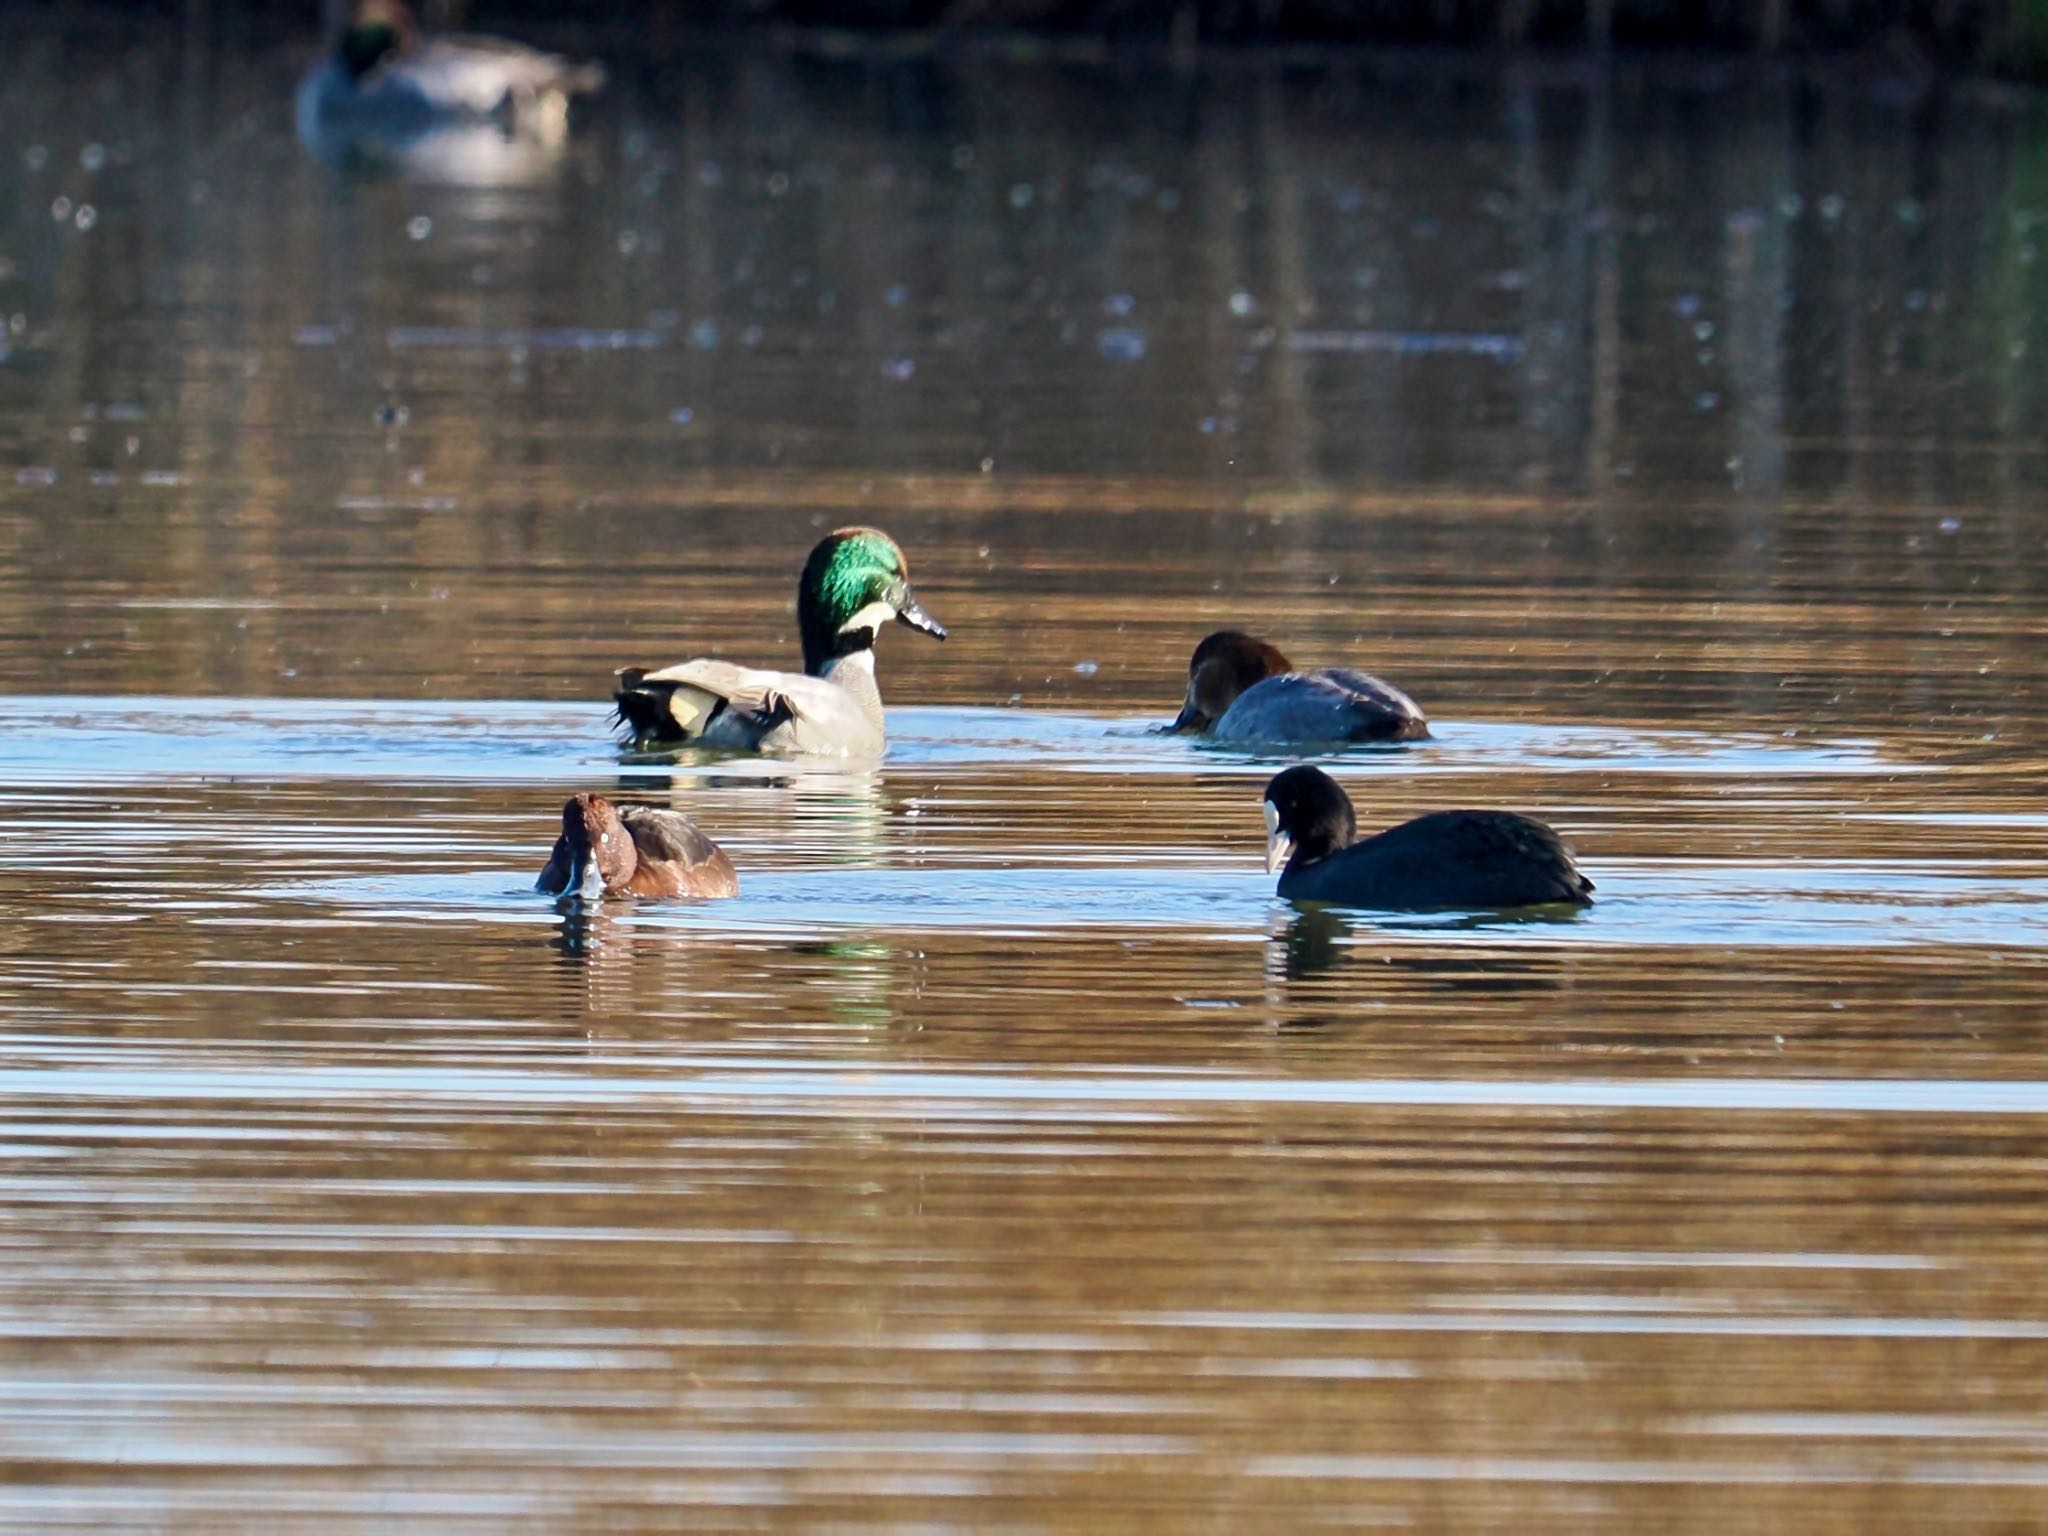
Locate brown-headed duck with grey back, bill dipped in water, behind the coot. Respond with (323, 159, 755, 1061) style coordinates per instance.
(1169, 629, 1430, 741)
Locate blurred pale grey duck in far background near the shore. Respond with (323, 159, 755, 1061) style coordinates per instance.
(299, 0, 604, 139)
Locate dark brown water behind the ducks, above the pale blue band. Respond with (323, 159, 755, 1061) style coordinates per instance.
(0, 20, 2048, 723)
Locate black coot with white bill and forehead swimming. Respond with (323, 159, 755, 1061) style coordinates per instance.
(1266, 766, 1593, 911)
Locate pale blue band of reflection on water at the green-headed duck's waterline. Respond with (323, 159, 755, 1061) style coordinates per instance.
(0, 694, 1916, 797)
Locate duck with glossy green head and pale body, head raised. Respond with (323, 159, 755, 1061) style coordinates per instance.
(612, 528, 946, 758)
